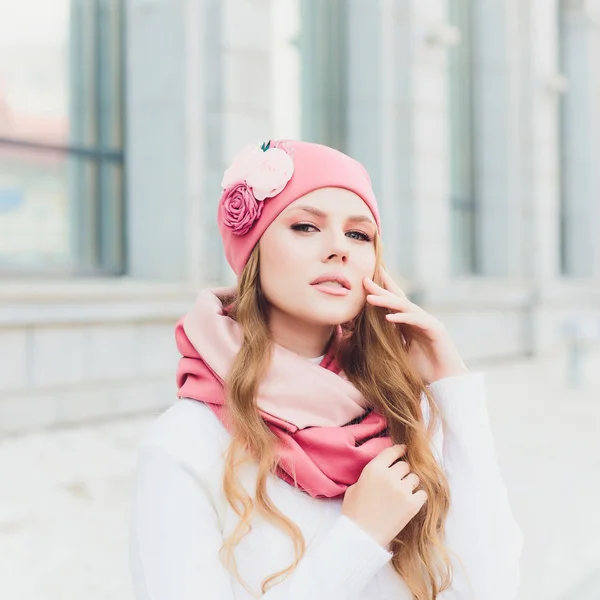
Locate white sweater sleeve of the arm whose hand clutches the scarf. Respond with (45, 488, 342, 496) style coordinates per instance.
(130, 446, 392, 600)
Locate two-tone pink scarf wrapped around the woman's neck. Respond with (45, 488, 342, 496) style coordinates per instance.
(175, 289, 393, 498)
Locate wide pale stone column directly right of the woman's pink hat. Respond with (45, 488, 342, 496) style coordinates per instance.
(348, 0, 450, 286)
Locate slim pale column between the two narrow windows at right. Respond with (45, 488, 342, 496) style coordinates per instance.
(472, 0, 527, 277)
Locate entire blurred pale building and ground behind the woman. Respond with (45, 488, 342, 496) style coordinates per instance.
(0, 0, 600, 600)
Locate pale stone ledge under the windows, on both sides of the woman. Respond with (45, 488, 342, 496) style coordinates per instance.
(0, 277, 600, 328)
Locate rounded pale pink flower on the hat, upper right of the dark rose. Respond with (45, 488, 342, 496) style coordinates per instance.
(246, 148, 294, 200)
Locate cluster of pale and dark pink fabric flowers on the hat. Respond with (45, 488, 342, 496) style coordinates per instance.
(221, 142, 294, 235)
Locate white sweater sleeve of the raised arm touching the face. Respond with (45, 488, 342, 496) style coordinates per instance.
(429, 373, 523, 600)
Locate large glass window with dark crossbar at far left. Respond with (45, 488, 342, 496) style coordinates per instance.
(0, 0, 124, 275)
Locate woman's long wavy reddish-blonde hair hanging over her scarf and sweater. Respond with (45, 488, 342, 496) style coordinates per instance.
(219, 237, 452, 600)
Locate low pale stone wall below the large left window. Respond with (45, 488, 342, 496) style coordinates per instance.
(0, 282, 193, 434)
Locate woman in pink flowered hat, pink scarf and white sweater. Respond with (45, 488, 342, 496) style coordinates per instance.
(131, 140, 522, 600)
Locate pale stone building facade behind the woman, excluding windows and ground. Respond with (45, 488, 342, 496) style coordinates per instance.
(0, 0, 600, 433)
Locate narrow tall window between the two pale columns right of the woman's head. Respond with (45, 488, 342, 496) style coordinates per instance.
(448, 0, 477, 275)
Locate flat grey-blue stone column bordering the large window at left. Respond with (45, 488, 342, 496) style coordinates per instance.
(125, 0, 189, 281)
